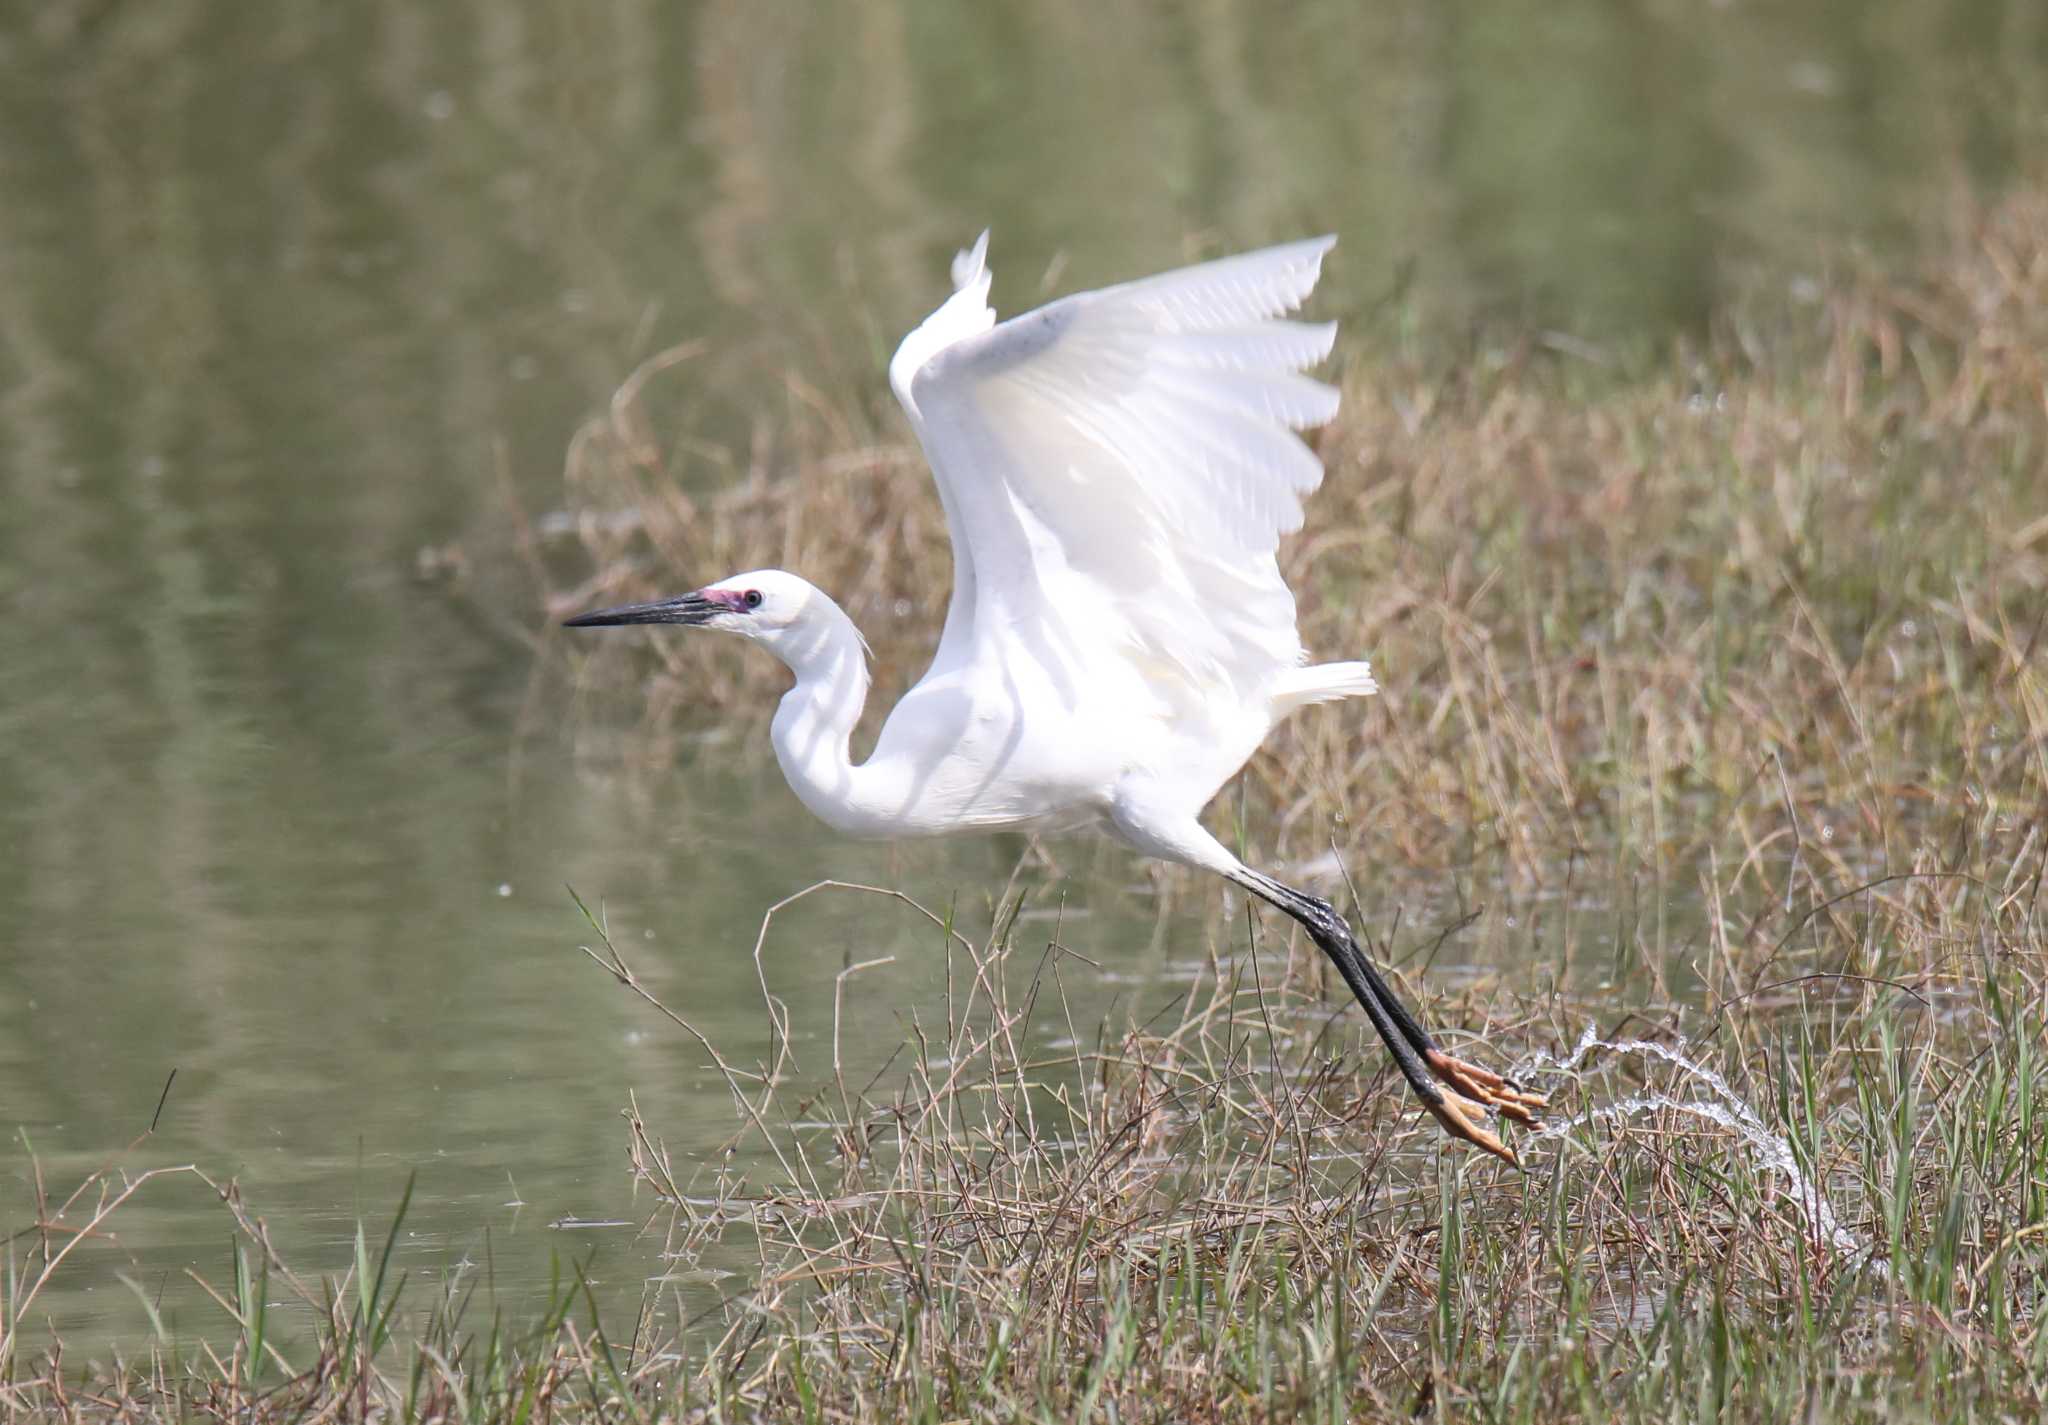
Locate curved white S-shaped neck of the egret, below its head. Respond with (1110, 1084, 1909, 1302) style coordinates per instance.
(762, 596, 877, 835)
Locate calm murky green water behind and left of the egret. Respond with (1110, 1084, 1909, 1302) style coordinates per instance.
(0, 0, 2048, 1349)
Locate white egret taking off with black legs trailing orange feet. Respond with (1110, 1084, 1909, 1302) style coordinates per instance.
(567, 233, 1544, 1163)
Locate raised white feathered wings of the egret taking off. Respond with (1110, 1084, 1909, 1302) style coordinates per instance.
(889, 233, 1337, 716)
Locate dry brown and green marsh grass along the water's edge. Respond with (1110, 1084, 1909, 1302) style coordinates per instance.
(0, 190, 2048, 1421)
